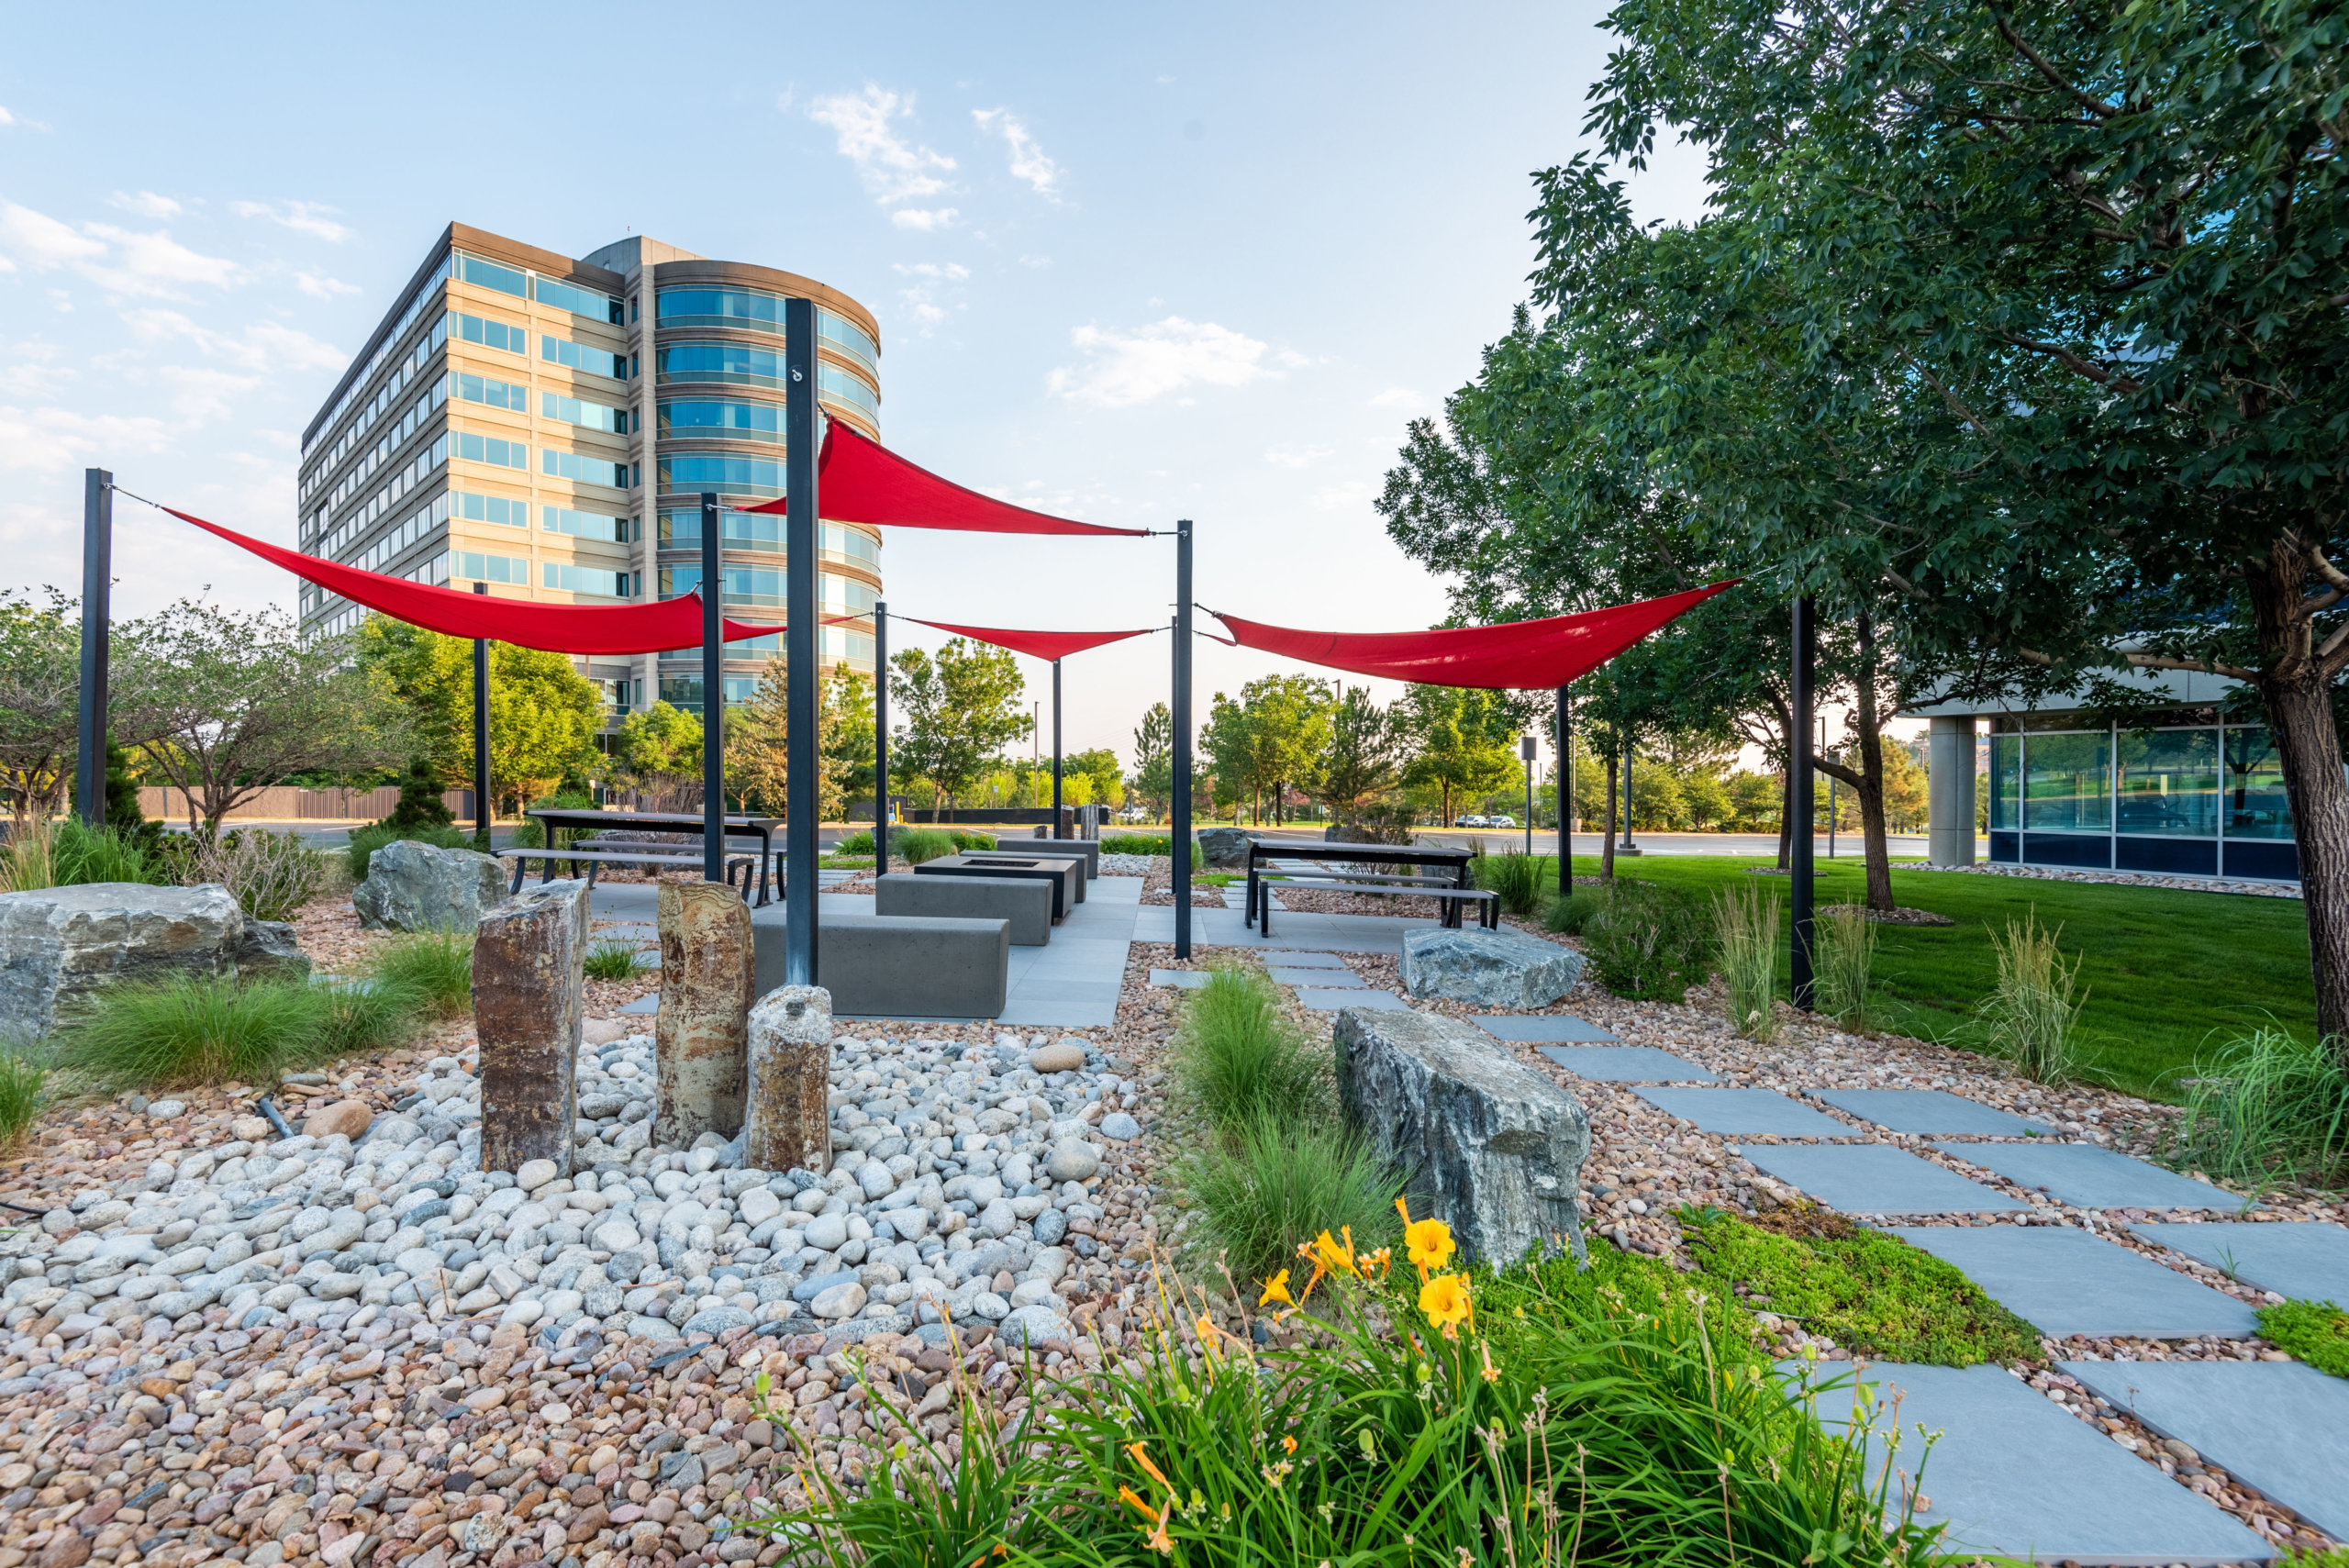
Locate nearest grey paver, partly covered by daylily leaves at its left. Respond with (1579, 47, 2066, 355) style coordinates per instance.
(1790, 1361, 2274, 1563)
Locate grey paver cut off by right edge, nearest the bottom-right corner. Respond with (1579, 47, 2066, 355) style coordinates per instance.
(2058, 1362, 2349, 1540)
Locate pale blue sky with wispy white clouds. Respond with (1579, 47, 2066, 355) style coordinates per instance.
(0, 5, 1698, 753)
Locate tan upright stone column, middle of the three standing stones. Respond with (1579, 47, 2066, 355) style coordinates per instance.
(653, 883, 751, 1148)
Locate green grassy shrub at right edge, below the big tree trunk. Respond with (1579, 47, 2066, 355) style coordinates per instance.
(2164, 1029, 2349, 1185)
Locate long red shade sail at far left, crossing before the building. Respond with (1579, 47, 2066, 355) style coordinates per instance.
(164, 507, 798, 652)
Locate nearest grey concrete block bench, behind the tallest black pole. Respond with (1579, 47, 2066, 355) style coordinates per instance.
(751, 904, 1012, 1018)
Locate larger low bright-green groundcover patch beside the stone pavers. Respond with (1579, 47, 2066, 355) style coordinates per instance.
(1682, 1211, 2039, 1366)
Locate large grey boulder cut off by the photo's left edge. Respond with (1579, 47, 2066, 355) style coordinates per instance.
(0, 883, 310, 1035)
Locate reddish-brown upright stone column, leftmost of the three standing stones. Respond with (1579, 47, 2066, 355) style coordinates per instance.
(473, 880, 587, 1176)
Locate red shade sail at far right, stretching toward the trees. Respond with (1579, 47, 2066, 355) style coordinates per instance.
(1209, 577, 1738, 690)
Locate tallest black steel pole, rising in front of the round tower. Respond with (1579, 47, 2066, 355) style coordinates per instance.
(782, 298, 822, 986)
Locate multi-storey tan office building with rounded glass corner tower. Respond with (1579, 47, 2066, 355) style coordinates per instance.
(296, 223, 881, 716)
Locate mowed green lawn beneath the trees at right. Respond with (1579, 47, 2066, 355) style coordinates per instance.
(1574, 854, 2316, 1098)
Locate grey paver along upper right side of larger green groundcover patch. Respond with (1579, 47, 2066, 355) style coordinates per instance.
(1891, 1225, 2260, 1340)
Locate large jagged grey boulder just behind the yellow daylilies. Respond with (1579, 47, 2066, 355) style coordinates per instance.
(1332, 1007, 1590, 1268)
